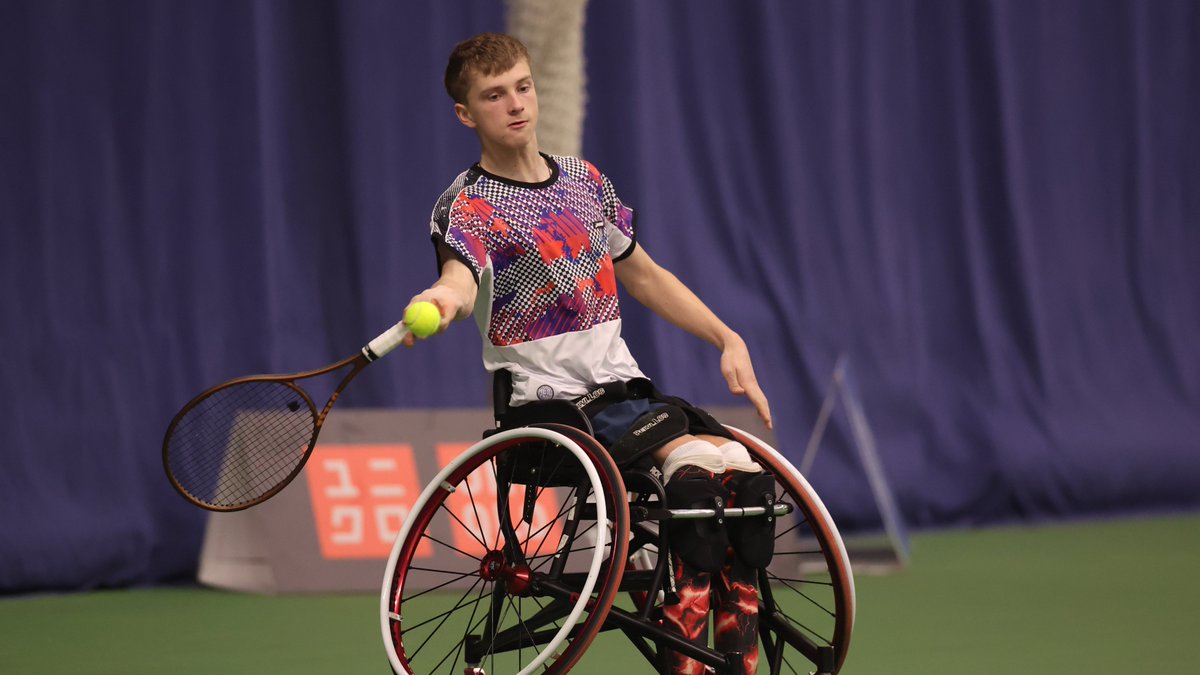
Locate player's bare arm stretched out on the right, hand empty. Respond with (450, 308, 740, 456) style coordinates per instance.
(614, 245, 772, 429)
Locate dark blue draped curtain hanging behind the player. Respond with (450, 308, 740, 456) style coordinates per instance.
(0, 0, 1200, 592)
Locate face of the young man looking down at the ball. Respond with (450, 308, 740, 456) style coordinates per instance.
(454, 60, 538, 149)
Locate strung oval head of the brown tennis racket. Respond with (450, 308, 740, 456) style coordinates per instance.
(169, 381, 316, 507)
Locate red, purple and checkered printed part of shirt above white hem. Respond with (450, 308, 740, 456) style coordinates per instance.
(443, 161, 632, 346)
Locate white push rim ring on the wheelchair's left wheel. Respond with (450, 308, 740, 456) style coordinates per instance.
(379, 426, 609, 675)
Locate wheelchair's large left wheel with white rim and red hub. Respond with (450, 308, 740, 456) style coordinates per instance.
(380, 425, 629, 675)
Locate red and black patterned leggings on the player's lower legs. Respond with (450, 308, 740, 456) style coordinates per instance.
(662, 549, 758, 675)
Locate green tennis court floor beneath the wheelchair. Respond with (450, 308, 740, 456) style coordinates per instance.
(0, 516, 1200, 675)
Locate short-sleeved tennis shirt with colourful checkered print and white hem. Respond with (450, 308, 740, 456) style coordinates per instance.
(430, 155, 643, 405)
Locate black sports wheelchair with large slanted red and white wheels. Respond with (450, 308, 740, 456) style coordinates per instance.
(380, 378, 854, 675)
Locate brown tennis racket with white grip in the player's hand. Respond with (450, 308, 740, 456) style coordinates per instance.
(162, 322, 408, 510)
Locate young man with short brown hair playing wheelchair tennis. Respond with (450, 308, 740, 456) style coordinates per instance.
(408, 34, 773, 673)
